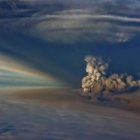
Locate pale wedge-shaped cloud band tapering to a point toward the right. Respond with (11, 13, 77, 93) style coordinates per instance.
(0, 54, 63, 88)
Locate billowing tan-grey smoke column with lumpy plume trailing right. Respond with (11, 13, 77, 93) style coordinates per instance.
(82, 56, 140, 96)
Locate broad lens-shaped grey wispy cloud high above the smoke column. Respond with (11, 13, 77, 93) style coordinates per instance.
(26, 10, 140, 43)
